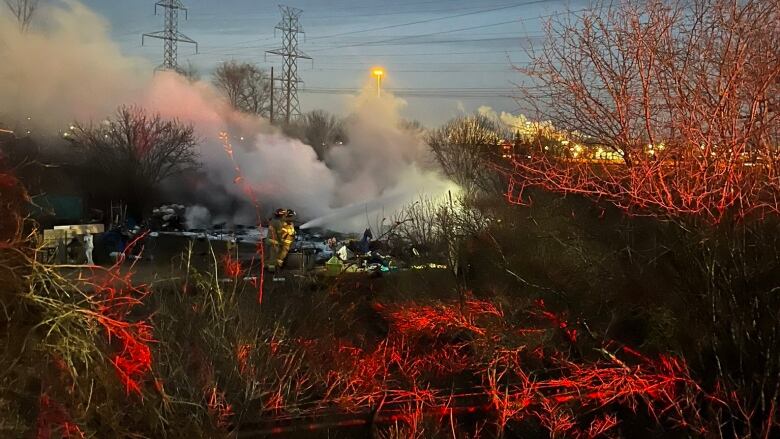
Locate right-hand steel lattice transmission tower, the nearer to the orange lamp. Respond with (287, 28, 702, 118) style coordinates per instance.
(266, 5, 311, 124)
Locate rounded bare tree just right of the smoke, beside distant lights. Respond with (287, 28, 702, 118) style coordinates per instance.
(427, 115, 507, 192)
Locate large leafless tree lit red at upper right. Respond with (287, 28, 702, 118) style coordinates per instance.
(515, 0, 780, 221)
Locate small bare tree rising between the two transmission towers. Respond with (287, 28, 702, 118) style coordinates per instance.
(213, 61, 272, 116)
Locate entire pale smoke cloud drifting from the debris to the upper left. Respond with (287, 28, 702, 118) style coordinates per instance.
(0, 0, 455, 231)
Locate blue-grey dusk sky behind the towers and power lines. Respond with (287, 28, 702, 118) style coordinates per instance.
(84, 0, 581, 125)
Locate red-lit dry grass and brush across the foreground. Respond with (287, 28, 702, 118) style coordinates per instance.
(0, 187, 720, 437)
